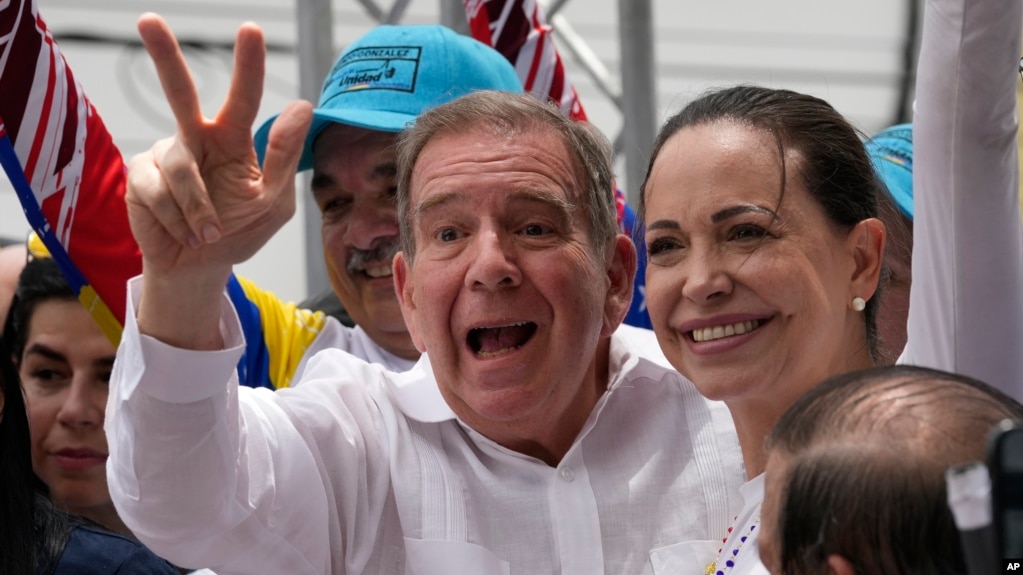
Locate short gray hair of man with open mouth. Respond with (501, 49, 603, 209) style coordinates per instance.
(397, 90, 618, 262)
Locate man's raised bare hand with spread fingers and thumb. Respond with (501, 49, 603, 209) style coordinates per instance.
(127, 14, 312, 348)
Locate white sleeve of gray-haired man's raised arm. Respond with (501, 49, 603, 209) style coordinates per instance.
(105, 278, 333, 573)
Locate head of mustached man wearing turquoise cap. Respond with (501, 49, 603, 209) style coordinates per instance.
(255, 25, 522, 359)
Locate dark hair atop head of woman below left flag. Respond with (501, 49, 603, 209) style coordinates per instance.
(3, 258, 77, 361)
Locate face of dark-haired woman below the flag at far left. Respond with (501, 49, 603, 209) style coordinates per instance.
(18, 300, 116, 516)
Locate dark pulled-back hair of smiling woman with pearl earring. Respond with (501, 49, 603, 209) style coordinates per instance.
(639, 85, 884, 360)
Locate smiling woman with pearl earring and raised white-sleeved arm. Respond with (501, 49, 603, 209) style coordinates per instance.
(640, 0, 1023, 575)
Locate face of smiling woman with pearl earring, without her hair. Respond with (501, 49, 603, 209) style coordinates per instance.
(644, 121, 873, 406)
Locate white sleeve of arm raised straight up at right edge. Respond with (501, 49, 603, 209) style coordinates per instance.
(900, 0, 1023, 399)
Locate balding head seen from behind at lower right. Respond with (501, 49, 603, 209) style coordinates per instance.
(759, 365, 1023, 575)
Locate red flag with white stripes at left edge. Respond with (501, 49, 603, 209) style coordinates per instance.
(0, 0, 141, 342)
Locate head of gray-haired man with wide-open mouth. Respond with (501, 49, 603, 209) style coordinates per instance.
(394, 92, 636, 462)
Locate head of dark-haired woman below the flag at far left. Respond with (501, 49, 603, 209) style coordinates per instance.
(4, 257, 122, 533)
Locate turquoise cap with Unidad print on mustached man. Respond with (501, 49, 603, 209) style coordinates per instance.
(253, 25, 523, 172)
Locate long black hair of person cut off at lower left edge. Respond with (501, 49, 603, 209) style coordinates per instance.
(0, 325, 71, 573)
